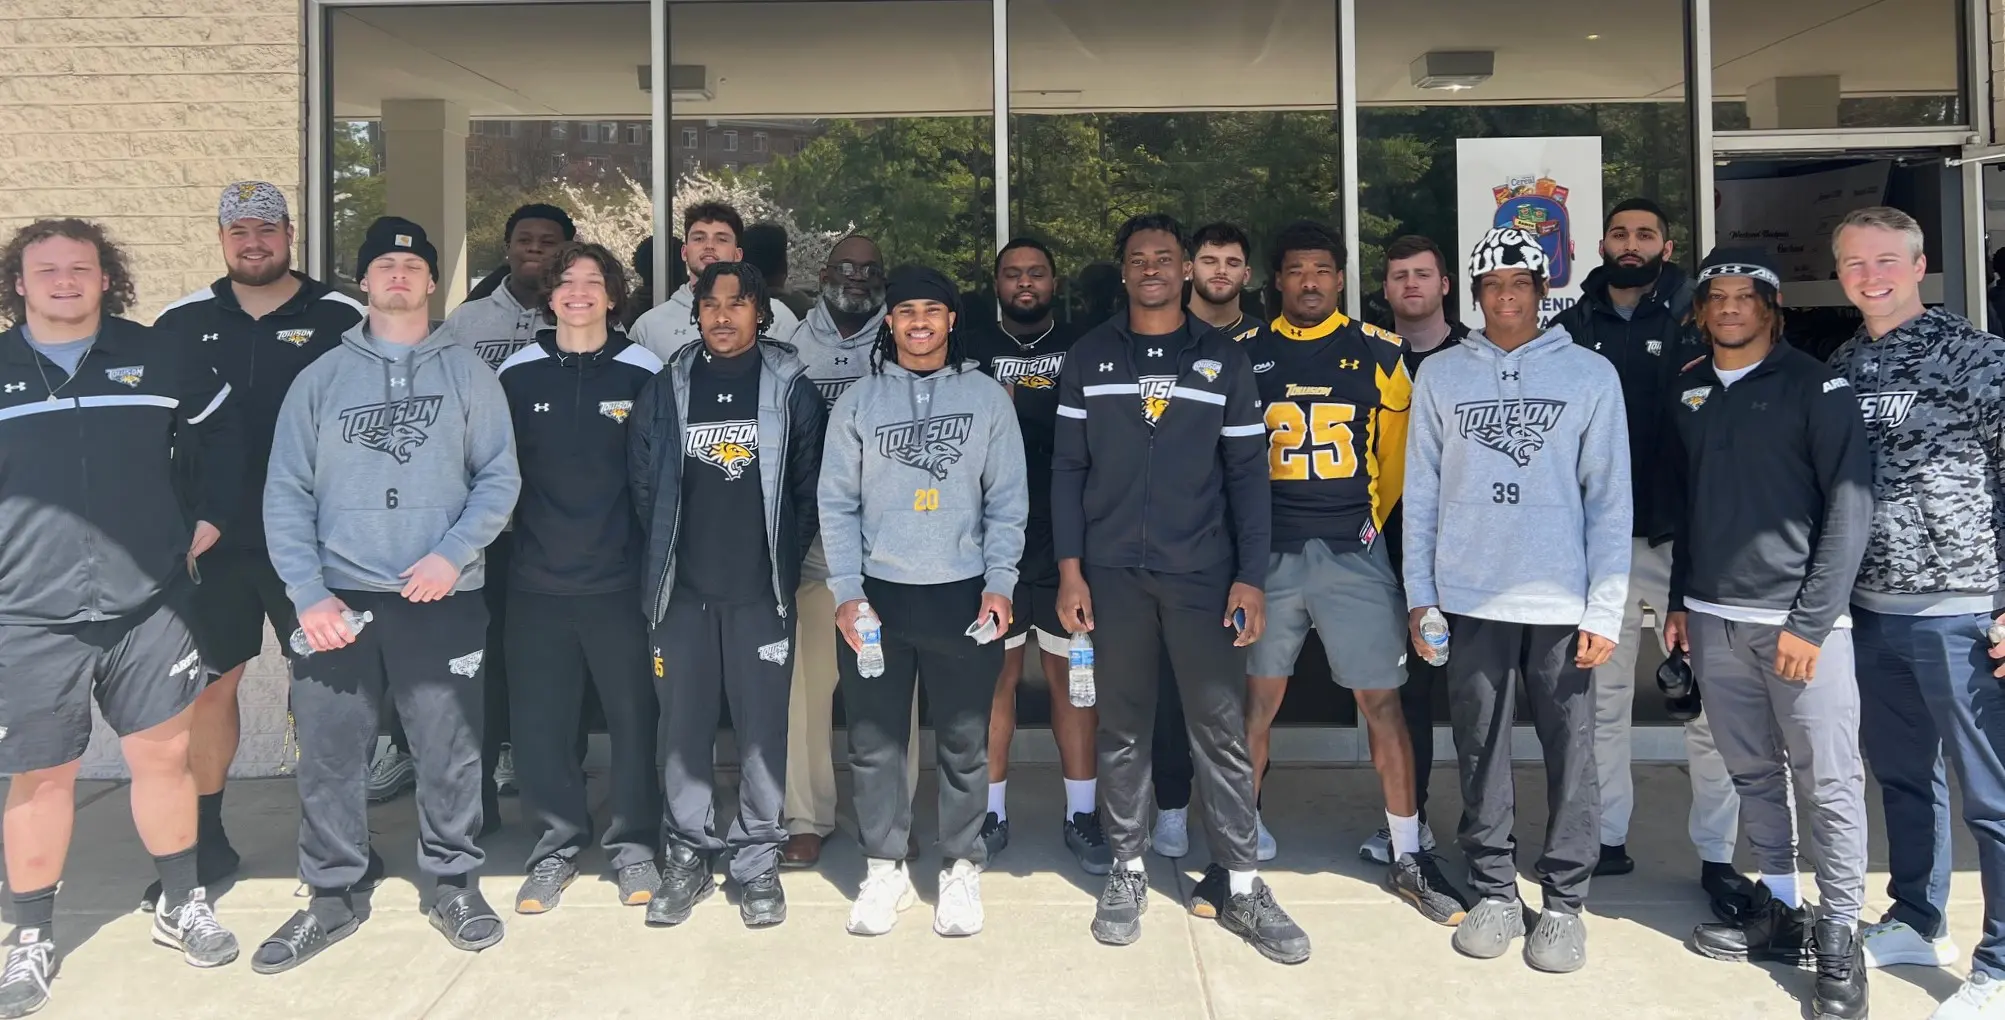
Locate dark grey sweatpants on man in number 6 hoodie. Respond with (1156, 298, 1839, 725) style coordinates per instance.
(293, 591, 487, 890)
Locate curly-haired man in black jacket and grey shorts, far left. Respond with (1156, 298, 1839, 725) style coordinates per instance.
(0, 218, 243, 1016)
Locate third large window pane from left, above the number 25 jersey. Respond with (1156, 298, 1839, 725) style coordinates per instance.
(1009, 0, 1343, 317)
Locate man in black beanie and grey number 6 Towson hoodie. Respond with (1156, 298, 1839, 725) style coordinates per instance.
(253, 216, 521, 974)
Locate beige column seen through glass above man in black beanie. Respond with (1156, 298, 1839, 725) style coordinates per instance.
(383, 98, 467, 319)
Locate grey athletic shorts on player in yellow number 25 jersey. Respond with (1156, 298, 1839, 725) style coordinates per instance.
(1247, 539, 1406, 691)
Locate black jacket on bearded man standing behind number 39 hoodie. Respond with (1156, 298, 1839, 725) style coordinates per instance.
(1552, 265, 1706, 545)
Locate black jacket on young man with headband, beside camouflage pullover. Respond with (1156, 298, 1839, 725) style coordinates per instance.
(1664, 345, 1873, 645)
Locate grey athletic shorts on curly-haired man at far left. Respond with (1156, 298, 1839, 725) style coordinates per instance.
(0, 585, 209, 776)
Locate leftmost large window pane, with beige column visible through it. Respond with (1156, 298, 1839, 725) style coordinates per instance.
(323, 2, 654, 300)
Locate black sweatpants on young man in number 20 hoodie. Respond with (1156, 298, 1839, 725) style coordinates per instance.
(836, 577, 1003, 864)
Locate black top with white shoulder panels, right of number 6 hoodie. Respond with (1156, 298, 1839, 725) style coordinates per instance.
(501, 329, 662, 595)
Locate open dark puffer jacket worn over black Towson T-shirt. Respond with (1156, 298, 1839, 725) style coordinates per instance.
(628, 339, 828, 625)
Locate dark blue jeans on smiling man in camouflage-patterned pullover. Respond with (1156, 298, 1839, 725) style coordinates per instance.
(1853, 605, 2005, 978)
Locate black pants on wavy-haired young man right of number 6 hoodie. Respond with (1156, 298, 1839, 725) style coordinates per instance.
(505, 591, 662, 870)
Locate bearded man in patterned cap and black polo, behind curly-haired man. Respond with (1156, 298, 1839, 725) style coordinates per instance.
(154, 180, 363, 910)
